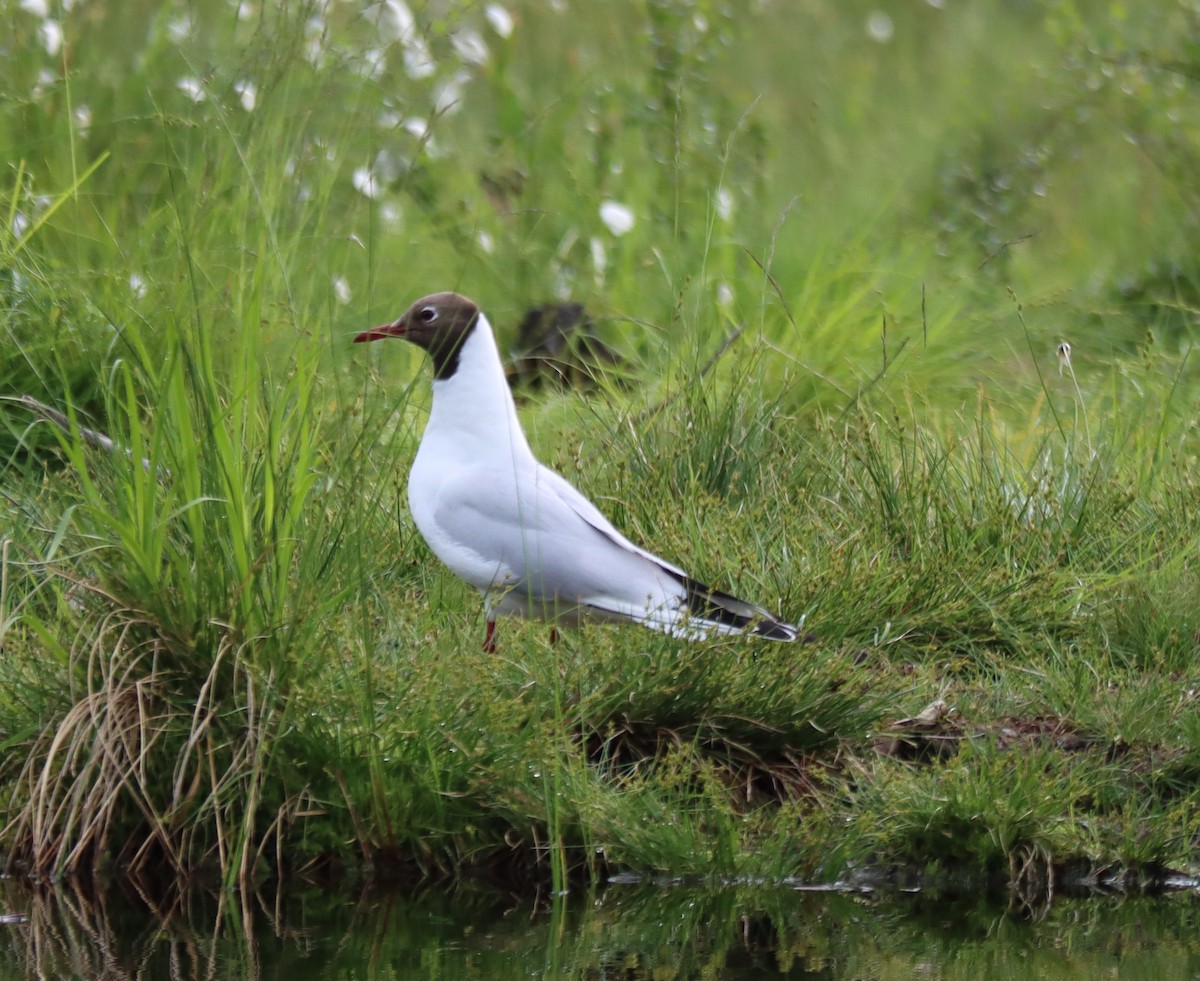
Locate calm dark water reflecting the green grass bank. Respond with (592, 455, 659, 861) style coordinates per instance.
(0, 881, 1200, 981)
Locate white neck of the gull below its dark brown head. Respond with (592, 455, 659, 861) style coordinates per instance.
(422, 313, 532, 456)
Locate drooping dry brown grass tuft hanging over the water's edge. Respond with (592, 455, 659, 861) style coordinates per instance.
(4, 573, 292, 879)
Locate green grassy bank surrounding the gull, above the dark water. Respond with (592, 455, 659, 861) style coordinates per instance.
(0, 2, 1200, 892)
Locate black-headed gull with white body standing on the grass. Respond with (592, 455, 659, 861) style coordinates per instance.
(354, 293, 797, 650)
